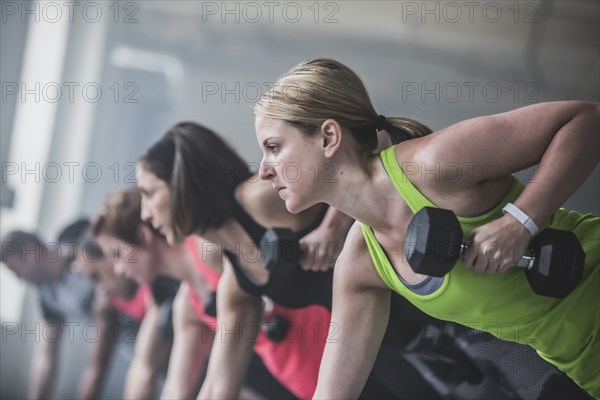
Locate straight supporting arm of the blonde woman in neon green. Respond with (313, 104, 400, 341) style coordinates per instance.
(314, 223, 390, 399)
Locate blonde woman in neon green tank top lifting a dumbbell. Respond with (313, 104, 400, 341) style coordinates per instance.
(254, 58, 600, 398)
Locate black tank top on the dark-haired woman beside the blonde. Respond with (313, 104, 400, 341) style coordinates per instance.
(225, 202, 333, 310)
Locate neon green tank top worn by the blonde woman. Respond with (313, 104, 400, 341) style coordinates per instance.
(362, 146, 600, 398)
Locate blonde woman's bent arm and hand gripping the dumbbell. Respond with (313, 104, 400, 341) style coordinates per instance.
(424, 101, 600, 273)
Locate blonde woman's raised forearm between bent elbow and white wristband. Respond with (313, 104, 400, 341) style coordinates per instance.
(515, 103, 600, 226)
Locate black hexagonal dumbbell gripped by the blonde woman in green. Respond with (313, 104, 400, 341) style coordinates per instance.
(404, 207, 585, 298)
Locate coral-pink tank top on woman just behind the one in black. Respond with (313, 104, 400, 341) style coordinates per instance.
(185, 236, 331, 399)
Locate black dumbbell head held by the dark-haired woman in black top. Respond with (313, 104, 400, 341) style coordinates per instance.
(260, 228, 302, 274)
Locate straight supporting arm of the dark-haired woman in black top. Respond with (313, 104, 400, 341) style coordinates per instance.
(198, 262, 262, 399)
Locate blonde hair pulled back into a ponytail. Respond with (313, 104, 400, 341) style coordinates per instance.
(254, 58, 431, 151)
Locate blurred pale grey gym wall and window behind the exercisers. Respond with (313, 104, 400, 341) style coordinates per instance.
(0, 0, 600, 398)
